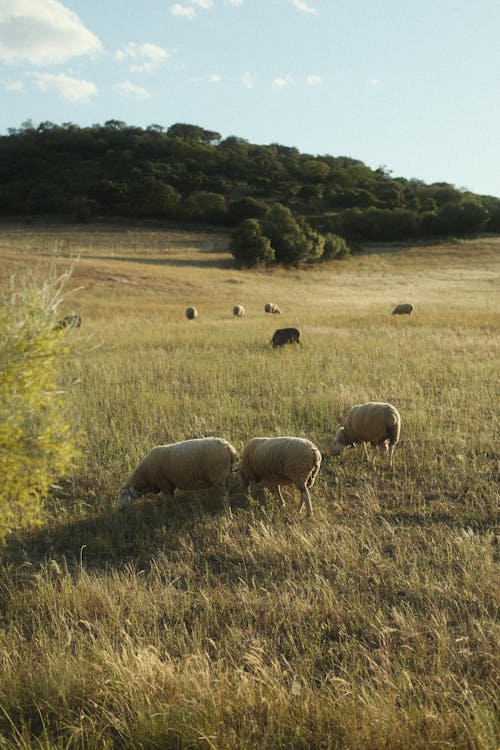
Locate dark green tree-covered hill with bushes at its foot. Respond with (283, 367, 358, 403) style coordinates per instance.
(0, 120, 500, 253)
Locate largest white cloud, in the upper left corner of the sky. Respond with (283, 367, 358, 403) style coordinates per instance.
(0, 0, 102, 65)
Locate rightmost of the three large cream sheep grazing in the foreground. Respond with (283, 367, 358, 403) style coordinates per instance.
(333, 401, 401, 470)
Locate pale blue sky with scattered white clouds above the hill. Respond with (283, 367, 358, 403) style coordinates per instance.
(0, 0, 500, 197)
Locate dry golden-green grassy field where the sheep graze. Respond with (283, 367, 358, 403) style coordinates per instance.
(0, 226, 500, 750)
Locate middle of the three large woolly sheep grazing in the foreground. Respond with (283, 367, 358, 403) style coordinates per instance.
(238, 437, 321, 517)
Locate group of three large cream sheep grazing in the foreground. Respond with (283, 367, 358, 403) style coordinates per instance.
(118, 401, 401, 516)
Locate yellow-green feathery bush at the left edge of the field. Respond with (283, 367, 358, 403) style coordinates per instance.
(0, 277, 77, 541)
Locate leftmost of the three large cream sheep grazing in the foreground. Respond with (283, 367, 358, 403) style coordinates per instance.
(118, 437, 237, 510)
